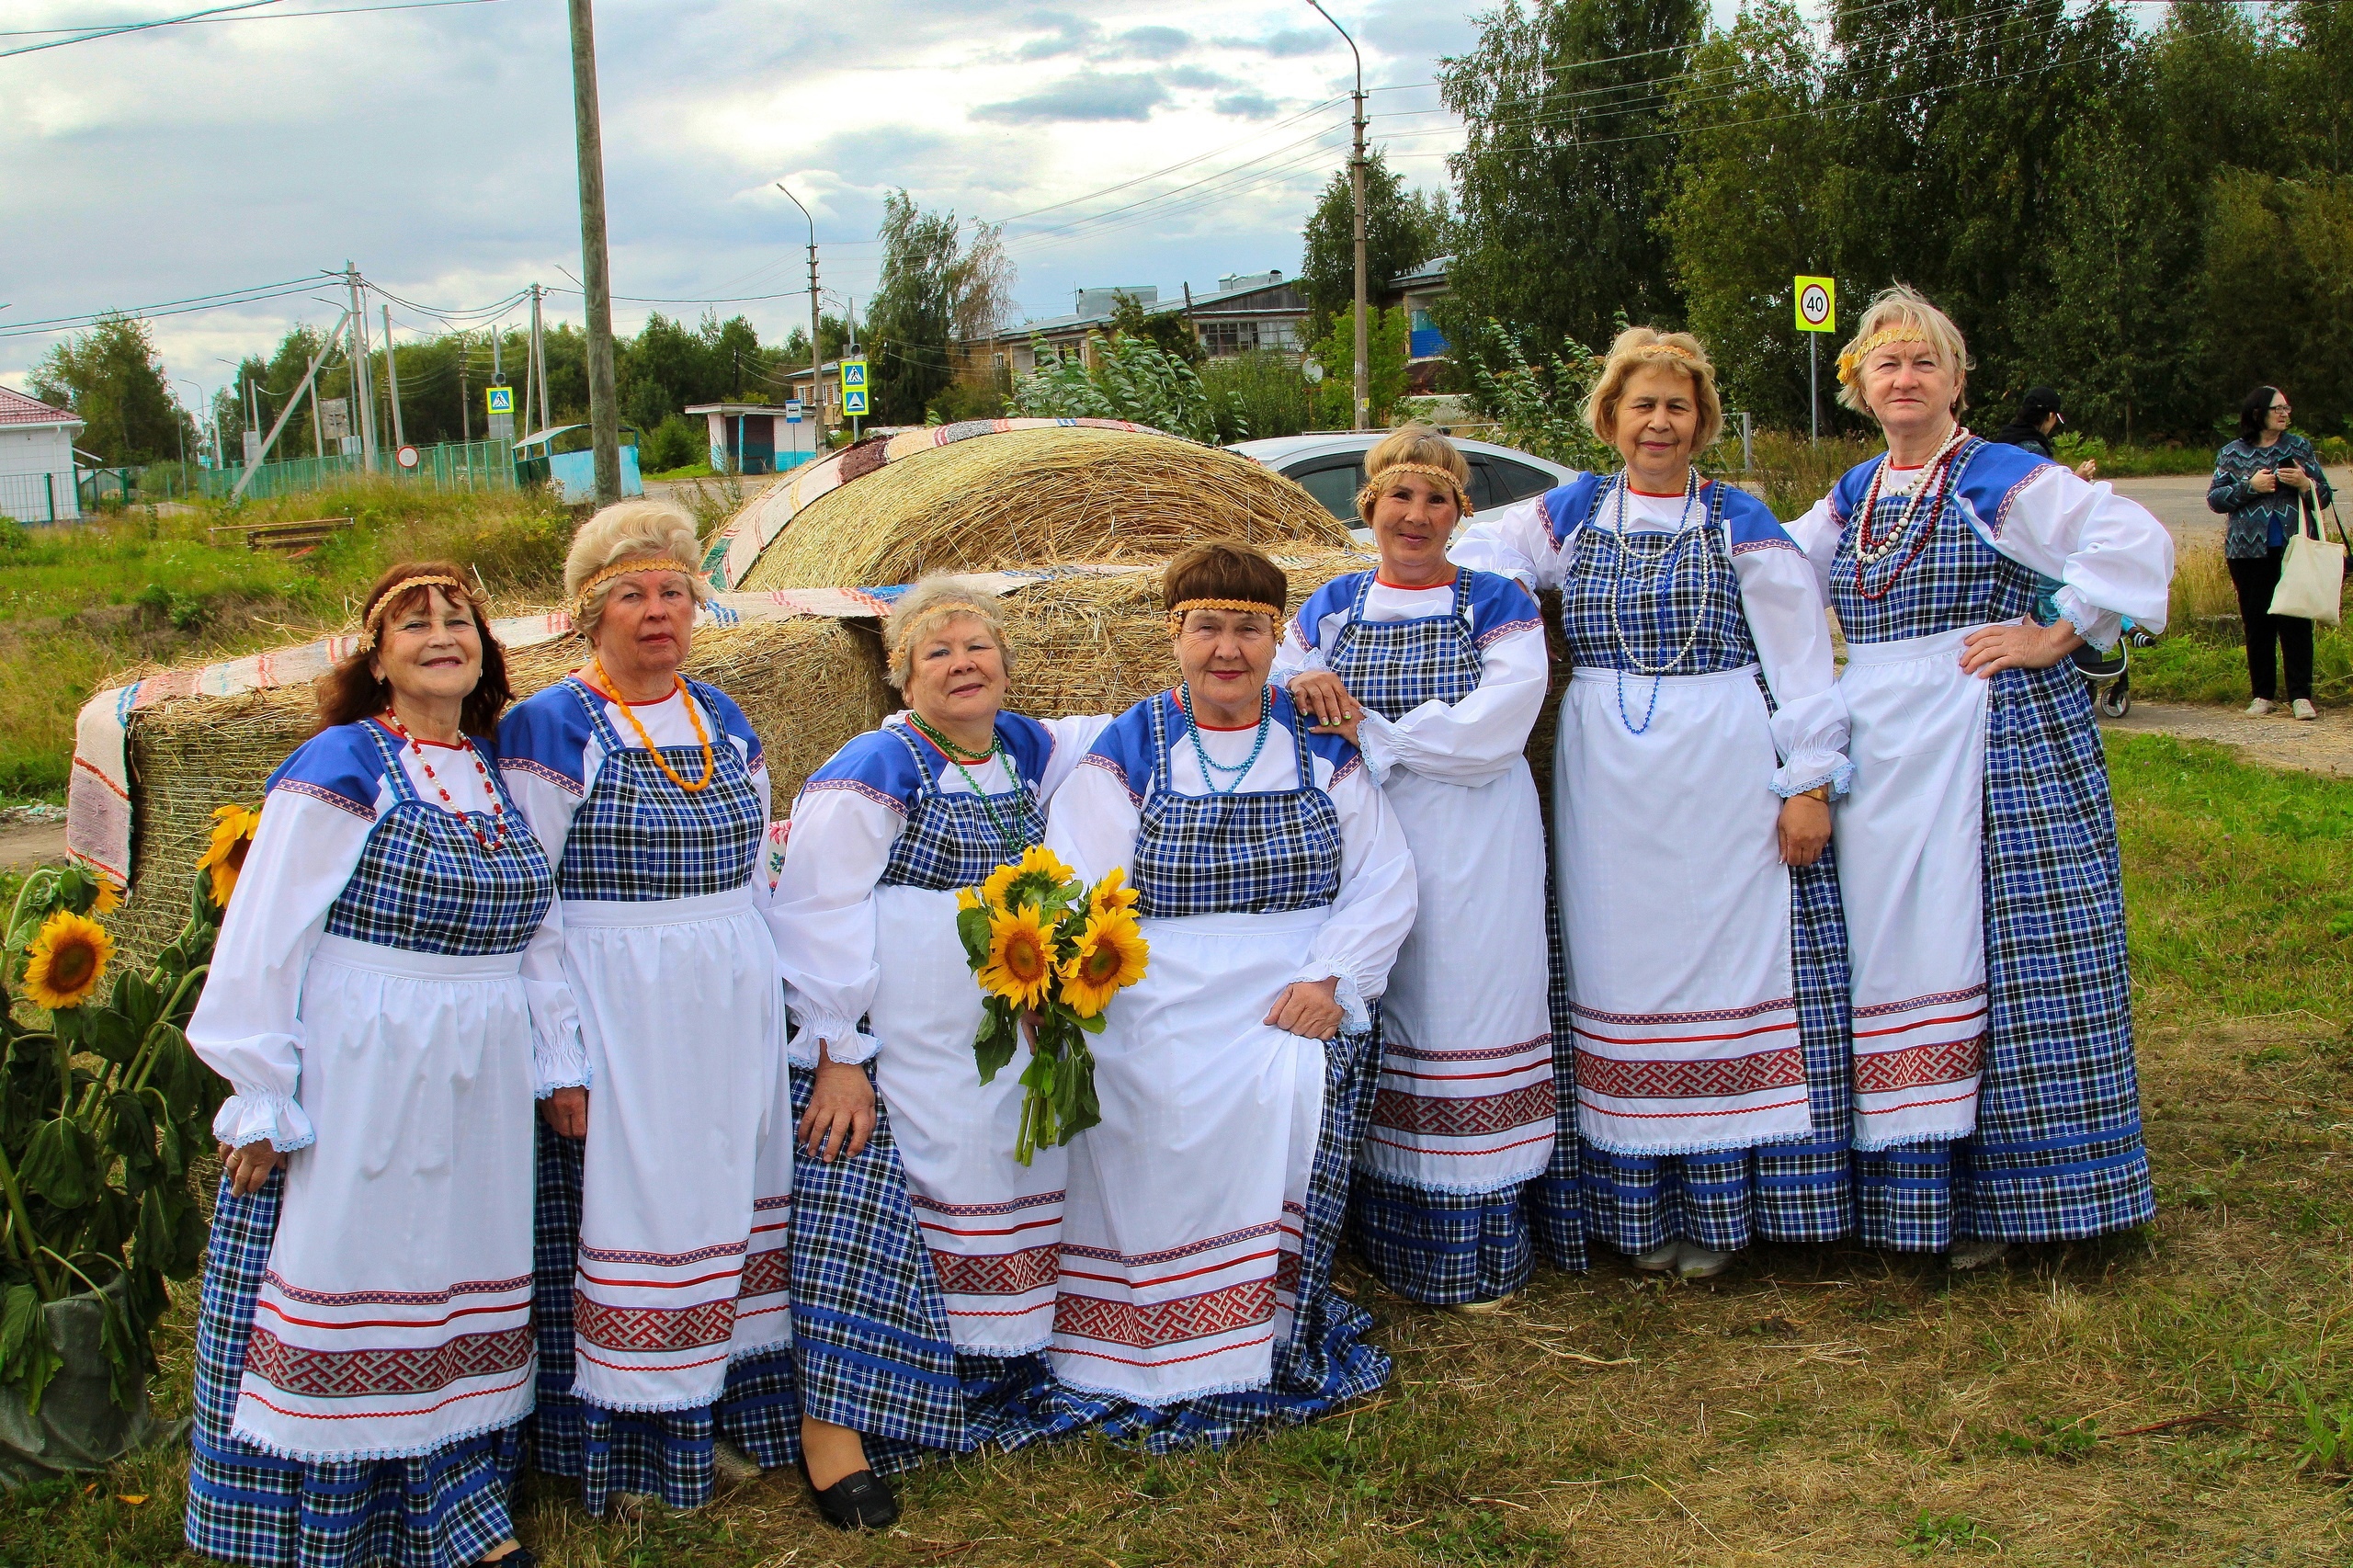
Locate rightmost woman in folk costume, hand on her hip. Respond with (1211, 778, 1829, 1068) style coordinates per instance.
(1790, 288, 2174, 1267)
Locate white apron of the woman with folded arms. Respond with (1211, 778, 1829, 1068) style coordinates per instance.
(1362, 760, 1553, 1191)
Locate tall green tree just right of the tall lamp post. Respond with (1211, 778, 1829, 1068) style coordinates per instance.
(1438, 0, 1701, 369)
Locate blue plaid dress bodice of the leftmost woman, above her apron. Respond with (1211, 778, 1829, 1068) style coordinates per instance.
(327, 722, 555, 956)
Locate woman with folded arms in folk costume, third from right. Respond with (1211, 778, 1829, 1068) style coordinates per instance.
(1276, 426, 1555, 1309)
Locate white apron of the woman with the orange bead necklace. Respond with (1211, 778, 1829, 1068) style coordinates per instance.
(563, 888, 793, 1410)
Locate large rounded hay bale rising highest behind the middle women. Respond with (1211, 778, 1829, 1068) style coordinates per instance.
(739, 428, 1348, 588)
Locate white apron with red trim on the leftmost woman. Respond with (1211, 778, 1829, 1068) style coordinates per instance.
(233, 935, 537, 1460)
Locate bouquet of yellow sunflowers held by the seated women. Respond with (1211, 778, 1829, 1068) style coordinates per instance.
(955, 846, 1146, 1165)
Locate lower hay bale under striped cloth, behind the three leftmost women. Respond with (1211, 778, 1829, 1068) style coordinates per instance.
(110, 619, 899, 960)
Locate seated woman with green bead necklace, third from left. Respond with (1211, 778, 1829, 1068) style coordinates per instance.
(777, 577, 1108, 1528)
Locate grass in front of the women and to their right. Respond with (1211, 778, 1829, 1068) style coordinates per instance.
(0, 737, 2353, 1568)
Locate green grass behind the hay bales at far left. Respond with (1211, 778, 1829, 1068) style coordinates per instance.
(0, 481, 572, 801)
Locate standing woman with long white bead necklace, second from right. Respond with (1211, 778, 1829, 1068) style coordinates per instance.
(1454, 327, 1852, 1278)
